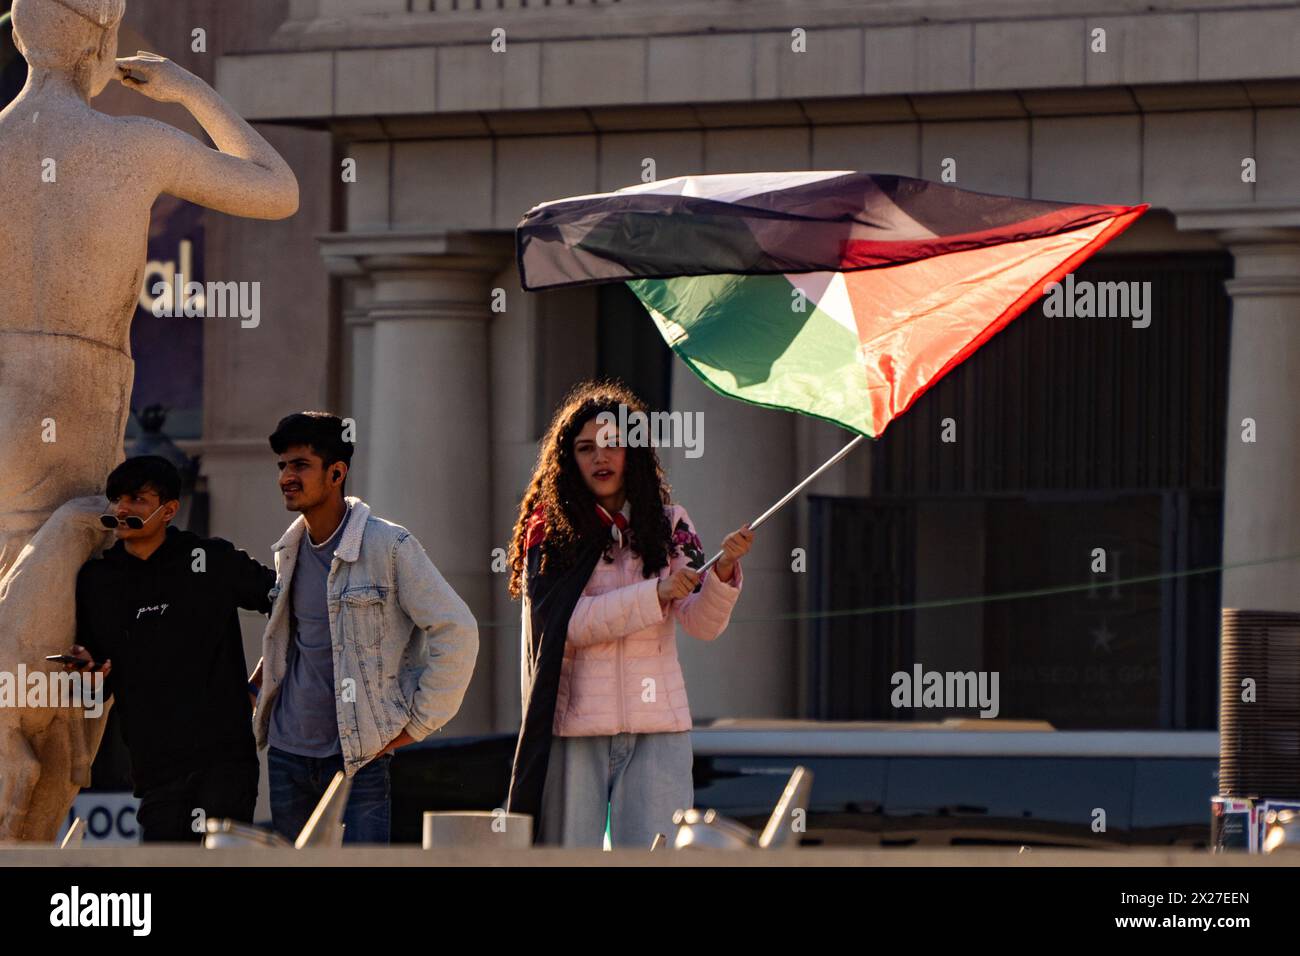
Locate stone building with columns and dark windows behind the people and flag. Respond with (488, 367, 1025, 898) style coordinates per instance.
(10, 0, 1300, 827)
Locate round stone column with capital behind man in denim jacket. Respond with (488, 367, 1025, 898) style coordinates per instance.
(321, 233, 512, 734)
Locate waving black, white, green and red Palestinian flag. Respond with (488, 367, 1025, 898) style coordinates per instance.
(516, 170, 1147, 437)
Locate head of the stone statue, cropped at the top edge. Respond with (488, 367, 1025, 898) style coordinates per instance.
(13, 0, 126, 96)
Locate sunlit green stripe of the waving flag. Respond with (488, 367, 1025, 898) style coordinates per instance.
(628, 276, 875, 438)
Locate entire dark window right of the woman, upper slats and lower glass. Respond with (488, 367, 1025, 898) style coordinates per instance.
(807, 254, 1231, 730)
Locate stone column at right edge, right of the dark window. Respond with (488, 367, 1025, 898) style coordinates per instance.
(1178, 207, 1300, 611)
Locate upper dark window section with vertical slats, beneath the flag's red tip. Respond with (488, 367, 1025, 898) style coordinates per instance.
(871, 254, 1231, 496)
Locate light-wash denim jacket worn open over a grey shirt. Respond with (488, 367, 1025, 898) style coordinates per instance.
(254, 498, 478, 777)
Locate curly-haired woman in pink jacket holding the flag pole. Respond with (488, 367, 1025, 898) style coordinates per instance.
(508, 382, 754, 848)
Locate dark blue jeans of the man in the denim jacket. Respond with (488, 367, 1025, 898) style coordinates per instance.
(267, 747, 393, 843)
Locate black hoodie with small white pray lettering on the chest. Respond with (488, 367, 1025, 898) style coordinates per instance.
(77, 528, 276, 796)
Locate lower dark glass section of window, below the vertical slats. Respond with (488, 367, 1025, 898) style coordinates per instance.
(809, 492, 1222, 730)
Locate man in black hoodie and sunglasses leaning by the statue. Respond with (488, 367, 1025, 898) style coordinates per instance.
(66, 457, 276, 843)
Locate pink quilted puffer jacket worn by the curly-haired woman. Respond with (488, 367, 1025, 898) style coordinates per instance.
(554, 505, 741, 737)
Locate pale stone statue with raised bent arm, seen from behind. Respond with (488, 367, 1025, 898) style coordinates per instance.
(0, 0, 298, 840)
